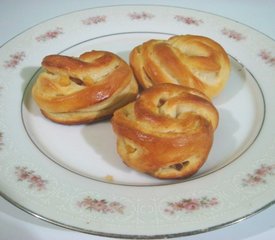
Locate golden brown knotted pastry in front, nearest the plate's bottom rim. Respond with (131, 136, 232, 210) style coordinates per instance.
(112, 83, 219, 179)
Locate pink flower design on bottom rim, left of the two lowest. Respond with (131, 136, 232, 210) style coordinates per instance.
(77, 196, 125, 214)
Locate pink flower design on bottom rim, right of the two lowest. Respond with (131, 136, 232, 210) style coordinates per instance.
(164, 197, 218, 214)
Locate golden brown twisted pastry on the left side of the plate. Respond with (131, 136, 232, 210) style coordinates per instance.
(32, 51, 138, 124)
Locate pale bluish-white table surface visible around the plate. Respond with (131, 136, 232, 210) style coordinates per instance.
(0, 0, 275, 240)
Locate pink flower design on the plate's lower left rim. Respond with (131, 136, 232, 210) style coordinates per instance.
(15, 166, 48, 191)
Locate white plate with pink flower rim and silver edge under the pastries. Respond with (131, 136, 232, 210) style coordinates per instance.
(0, 5, 275, 238)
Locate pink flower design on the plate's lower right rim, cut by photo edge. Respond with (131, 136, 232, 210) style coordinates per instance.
(242, 164, 275, 187)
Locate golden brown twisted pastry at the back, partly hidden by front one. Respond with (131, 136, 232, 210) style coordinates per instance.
(130, 35, 230, 98)
